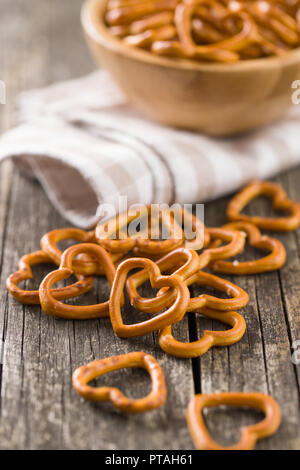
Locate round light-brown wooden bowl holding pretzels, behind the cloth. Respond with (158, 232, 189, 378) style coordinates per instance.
(81, 0, 300, 136)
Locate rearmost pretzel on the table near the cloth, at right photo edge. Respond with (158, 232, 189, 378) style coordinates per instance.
(227, 180, 300, 232)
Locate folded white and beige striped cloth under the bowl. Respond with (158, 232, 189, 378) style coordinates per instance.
(0, 71, 300, 228)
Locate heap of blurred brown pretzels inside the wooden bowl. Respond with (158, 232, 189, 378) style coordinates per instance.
(105, 0, 300, 63)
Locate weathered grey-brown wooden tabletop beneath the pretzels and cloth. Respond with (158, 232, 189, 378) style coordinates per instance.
(0, 0, 300, 449)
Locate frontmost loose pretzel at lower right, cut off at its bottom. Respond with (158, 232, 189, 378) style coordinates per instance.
(186, 392, 281, 450)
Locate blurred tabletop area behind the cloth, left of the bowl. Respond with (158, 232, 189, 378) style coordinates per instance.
(0, 0, 92, 133)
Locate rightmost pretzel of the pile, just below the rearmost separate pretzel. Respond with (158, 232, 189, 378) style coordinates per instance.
(209, 222, 286, 275)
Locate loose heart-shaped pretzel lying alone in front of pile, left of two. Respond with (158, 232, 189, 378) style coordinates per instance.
(72, 352, 167, 413)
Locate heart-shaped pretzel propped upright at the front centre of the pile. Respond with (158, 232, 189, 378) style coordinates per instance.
(109, 258, 190, 338)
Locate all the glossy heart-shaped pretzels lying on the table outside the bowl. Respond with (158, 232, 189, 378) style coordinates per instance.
(6, 180, 300, 449)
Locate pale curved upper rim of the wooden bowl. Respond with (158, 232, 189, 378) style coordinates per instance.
(81, 0, 300, 73)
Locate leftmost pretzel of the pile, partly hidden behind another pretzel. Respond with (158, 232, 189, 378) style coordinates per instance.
(6, 251, 93, 305)
